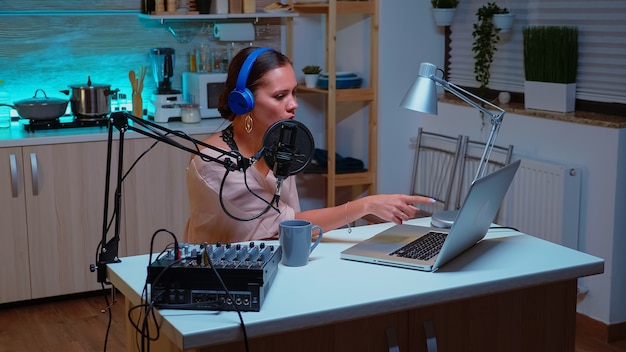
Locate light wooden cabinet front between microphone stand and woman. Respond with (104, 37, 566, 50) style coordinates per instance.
(122, 134, 209, 255)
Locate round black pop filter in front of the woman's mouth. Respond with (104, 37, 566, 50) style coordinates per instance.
(263, 120, 315, 180)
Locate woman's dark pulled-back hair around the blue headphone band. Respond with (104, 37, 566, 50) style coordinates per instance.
(217, 47, 291, 121)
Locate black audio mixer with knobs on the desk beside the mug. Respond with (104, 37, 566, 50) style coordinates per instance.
(147, 242, 281, 312)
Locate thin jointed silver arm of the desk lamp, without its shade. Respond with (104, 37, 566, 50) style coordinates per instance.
(430, 75, 505, 181)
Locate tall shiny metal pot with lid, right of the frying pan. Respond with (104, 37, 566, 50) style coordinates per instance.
(63, 77, 119, 119)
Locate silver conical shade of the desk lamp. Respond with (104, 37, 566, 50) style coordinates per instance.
(400, 62, 437, 115)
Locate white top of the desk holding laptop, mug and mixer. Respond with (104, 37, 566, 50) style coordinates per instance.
(108, 219, 604, 349)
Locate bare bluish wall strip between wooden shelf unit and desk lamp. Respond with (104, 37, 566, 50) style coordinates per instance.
(378, 0, 444, 193)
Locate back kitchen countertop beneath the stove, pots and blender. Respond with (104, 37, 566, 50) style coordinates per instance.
(0, 118, 229, 147)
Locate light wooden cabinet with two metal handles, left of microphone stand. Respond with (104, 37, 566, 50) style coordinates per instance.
(0, 142, 112, 302)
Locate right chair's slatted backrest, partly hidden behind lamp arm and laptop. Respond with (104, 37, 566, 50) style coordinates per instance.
(454, 138, 513, 210)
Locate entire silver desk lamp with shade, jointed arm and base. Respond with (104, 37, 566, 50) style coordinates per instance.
(401, 62, 505, 228)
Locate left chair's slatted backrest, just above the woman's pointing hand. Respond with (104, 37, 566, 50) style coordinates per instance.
(411, 127, 464, 214)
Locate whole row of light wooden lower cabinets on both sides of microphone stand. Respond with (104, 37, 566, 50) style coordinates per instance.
(0, 134, 209, 303)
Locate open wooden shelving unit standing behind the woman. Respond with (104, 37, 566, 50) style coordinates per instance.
(287, 0, 378, 206)
